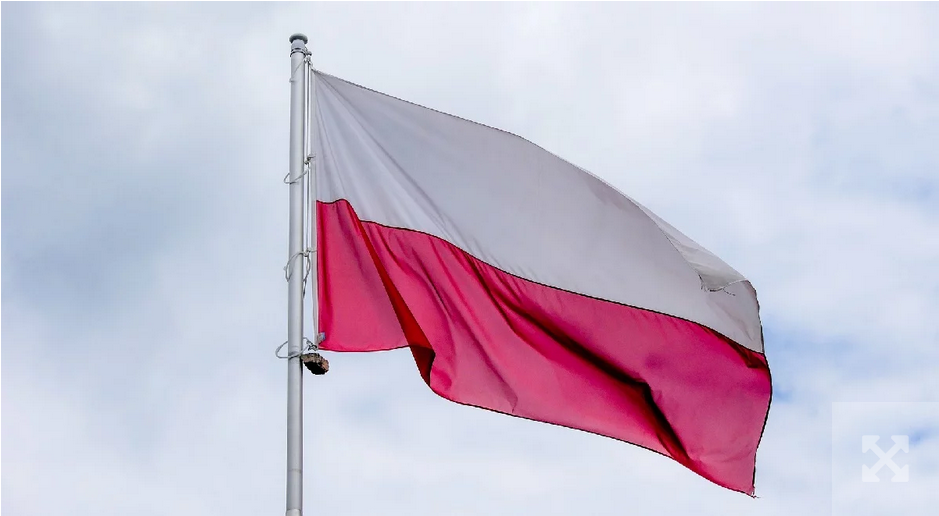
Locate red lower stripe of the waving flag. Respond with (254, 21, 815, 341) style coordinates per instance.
(317, 200, 771, 495)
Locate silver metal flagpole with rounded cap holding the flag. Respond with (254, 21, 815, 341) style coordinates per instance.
(286, 34, 316, 516)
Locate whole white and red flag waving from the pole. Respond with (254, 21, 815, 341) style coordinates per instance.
(313, 72, 770, 495)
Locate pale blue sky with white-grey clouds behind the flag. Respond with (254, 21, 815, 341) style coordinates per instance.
(0, 2, 939, 516)
